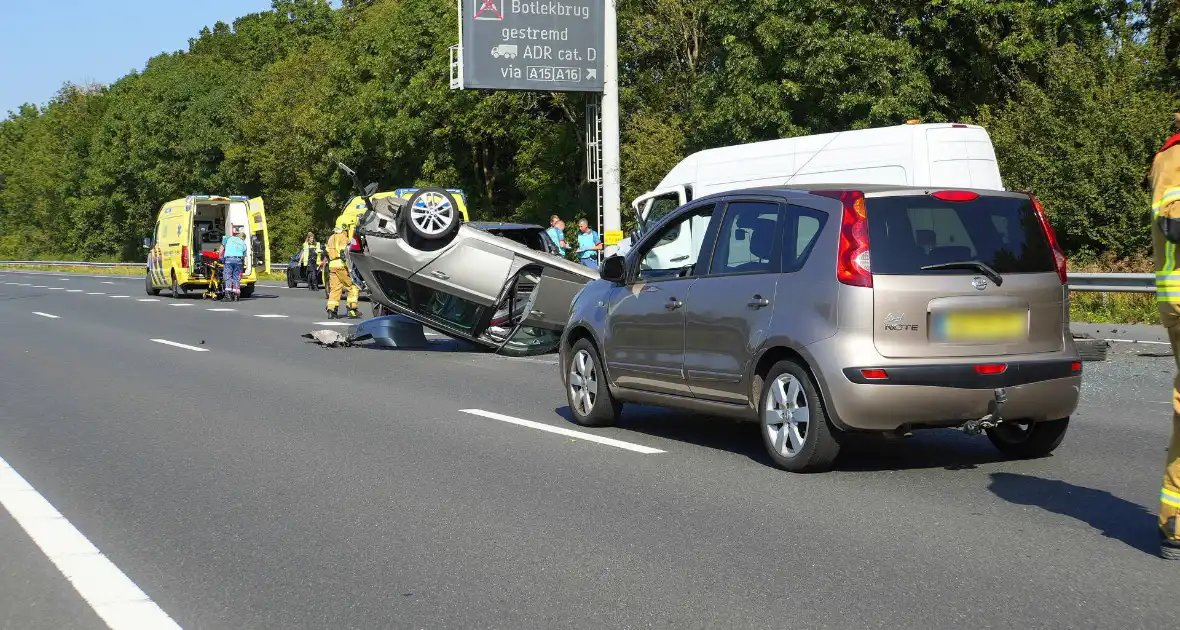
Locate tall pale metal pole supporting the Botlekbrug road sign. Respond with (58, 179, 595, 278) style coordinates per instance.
(602, 0, 623, 256)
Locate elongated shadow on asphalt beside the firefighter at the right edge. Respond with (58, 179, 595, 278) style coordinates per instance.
(988, 473, 1159, 556)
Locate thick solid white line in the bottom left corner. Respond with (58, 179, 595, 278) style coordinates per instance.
(0, 458, 181, 630)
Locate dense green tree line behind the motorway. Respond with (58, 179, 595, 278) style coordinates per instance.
(0, 0, 1180, 261)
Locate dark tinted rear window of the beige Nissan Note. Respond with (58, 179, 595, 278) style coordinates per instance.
(865, 195, 1055, 275)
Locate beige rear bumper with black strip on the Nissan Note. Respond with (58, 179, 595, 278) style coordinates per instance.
(815, 335, 1082, 431)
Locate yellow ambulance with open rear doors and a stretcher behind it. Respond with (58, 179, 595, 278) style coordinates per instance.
(144, 195, 270, 297)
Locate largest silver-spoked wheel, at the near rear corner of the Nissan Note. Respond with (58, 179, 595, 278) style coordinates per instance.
(759, 361, 841, 473)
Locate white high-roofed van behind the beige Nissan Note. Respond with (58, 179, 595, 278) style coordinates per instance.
(618, 123, 1004, 263)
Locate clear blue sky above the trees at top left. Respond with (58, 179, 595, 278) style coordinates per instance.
(0, 0, 270, 119)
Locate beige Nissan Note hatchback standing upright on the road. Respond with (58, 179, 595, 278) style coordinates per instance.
(559, 185, 1082, 472)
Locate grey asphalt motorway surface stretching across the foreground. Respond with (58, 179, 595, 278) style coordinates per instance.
(0, 273, 1180, 629)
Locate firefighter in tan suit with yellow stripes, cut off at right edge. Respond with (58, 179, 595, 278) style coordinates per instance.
(1152, 113, 1180, 560)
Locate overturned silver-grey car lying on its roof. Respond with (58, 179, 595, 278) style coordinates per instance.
(350, 188, 598, 356)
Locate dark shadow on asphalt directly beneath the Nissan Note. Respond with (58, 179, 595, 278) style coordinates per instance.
(555, 405, 1005, 472)
